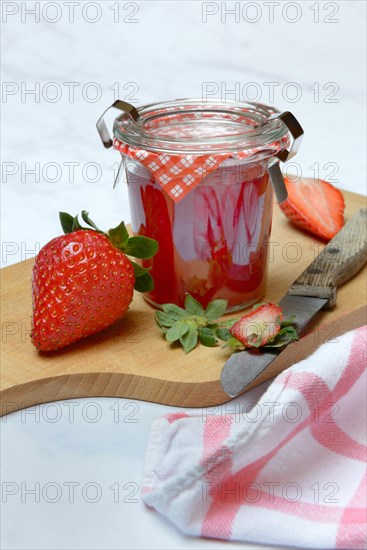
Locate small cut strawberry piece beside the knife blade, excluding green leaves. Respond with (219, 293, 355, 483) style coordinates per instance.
(229, 303, 284, 348)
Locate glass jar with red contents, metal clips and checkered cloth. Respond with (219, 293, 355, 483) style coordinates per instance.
(97, 99, 303, 311)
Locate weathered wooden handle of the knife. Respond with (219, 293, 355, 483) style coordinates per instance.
(288, 208, 367, 308)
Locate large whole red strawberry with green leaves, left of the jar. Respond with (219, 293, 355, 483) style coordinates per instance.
(31, 211, 158, 351)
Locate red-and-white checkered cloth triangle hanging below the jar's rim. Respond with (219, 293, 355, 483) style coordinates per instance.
(113, 136, 289, 202)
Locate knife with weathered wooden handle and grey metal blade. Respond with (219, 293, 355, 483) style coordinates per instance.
(220, 208, 367, 397)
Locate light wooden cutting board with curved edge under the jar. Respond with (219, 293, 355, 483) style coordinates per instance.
(0, 192, 366, 415)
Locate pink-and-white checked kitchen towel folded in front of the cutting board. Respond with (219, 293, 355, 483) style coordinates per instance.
(143, 327, 367, 548)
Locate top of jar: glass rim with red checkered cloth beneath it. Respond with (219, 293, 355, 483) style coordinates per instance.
(113, 100, 289, 202)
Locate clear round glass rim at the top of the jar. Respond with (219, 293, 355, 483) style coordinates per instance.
(113, 98, 289, 154)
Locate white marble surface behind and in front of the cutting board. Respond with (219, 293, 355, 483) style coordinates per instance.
(1, 0, 366, 550)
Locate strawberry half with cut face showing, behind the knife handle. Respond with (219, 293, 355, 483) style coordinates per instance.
(279, 177, 345, 240)
